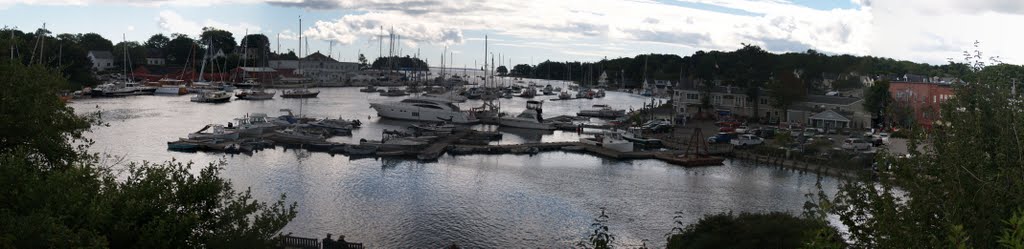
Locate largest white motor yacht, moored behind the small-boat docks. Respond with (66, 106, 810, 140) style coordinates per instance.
(370, 97, 478, 124)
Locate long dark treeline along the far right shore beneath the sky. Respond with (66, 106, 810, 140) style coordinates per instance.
(511, 45, 999, 87)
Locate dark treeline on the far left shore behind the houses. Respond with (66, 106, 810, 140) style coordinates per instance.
(0, 27, 298, 88)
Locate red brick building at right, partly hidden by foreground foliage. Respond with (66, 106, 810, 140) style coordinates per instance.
(889, 82, 953, 127)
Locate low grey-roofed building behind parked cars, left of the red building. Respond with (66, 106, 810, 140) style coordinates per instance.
(784, 95, 871, 129)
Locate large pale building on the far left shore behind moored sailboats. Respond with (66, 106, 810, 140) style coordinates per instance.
(269, 51, 359, 85)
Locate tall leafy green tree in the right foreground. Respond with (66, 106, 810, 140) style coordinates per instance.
(825, 45, 1024, 248)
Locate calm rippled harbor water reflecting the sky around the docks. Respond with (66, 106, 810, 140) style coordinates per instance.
(72, 86, 837, 248)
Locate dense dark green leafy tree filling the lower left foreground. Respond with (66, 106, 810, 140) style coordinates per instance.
(0, 64, 296, 248)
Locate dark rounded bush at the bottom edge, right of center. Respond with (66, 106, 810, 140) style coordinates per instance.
(667, 212, 842, 248)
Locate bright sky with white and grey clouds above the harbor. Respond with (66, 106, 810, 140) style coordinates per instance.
(0, 0, 1024, 68)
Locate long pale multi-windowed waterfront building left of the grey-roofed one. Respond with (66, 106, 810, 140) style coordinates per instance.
(672, 79, 779, 120)
